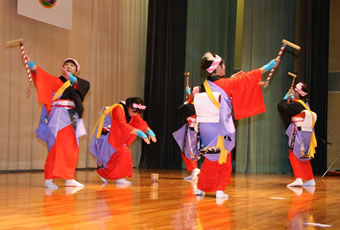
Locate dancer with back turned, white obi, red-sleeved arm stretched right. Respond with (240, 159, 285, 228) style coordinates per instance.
(194, 52, 279, 199)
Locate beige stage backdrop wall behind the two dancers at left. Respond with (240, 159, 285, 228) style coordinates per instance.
(0, 0, 148, 171)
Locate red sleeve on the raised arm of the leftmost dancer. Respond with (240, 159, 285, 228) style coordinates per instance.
(32, 66, 63, 111)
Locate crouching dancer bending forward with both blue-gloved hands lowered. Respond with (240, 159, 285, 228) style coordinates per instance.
(90, 97, 157, 184)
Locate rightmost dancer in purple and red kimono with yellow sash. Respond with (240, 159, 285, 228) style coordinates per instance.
(278, 82, 317, 187)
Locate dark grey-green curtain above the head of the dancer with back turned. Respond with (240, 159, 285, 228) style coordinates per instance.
(183, 0, 237, 86)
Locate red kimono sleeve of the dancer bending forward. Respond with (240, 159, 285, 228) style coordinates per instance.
(109, 106, 136, 150)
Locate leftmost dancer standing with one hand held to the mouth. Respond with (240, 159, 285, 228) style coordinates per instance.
(28, 58, 90, 189)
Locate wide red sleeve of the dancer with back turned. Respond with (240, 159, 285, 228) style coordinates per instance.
(214, 69, 266, 120)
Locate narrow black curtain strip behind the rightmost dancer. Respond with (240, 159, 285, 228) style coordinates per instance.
(298, 0, 330, 174)
